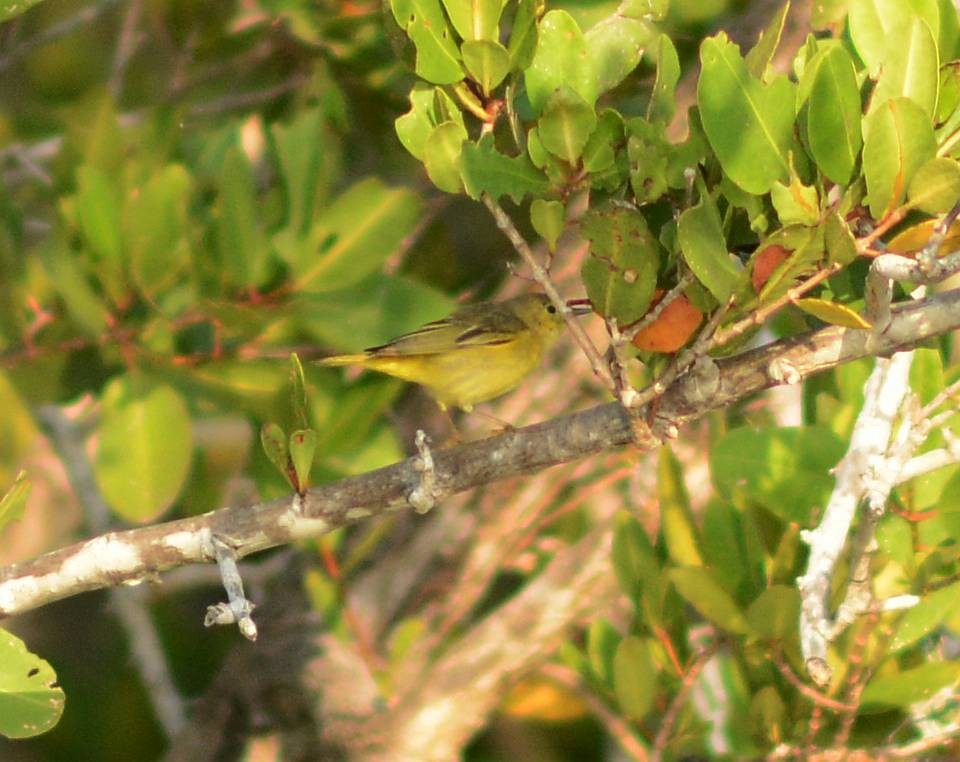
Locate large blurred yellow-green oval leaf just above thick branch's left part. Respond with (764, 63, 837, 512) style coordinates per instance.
(94, 376, 193, 522)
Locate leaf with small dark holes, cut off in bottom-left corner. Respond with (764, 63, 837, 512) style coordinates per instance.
(0, 630, 66, 738)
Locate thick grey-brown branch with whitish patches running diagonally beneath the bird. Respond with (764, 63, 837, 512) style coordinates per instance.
(0, 291, 960, 618)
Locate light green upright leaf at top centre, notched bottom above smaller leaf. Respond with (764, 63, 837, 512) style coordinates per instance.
(525, 10, 598, 114)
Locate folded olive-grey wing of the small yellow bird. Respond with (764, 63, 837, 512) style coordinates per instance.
(367, 304, 526, 357)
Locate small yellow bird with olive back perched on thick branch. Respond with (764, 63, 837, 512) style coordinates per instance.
(319, 294, 589, 412)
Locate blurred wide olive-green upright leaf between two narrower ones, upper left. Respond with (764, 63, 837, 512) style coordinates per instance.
(123, 164, 192, 300)
